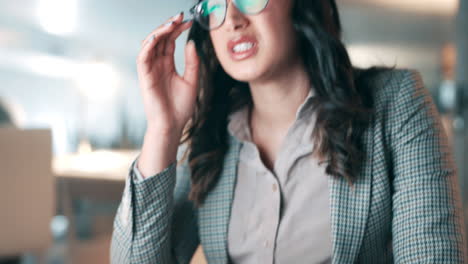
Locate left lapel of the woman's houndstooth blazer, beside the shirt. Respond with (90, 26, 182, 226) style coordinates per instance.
(198, 134, 241, 263)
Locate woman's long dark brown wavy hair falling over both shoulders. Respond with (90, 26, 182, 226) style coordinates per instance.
(181, 0, 383, 206)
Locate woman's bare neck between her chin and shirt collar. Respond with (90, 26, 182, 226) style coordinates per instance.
(249, 58, 310, 130)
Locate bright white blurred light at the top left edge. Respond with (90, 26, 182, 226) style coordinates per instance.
(37, 0, 78, 35)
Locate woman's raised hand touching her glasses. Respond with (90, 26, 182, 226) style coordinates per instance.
(137, 13, 199, 135)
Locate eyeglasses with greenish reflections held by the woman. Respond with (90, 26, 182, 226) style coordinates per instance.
(184, 0, 269, 30)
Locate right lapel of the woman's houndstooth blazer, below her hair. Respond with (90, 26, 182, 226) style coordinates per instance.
(329, 122, 374, 263)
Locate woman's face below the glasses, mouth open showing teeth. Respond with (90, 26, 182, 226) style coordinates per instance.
(210, 0, 297, 82)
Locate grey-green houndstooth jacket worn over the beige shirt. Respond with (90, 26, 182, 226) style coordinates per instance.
(111, 70, 466, 264)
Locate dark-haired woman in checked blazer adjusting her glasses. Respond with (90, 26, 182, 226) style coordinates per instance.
(111, 0, 465, 263)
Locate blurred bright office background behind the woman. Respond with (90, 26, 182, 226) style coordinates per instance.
(0, 0, 468, 263)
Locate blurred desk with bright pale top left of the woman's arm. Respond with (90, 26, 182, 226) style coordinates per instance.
(52, 150, 139, 240)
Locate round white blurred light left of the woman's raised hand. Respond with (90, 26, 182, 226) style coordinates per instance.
(75, 61, 119, 102)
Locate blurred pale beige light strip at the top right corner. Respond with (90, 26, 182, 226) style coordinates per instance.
(362, 0, 459, 15)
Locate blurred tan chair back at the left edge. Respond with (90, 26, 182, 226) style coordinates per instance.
(0, 126, 55, 263)
